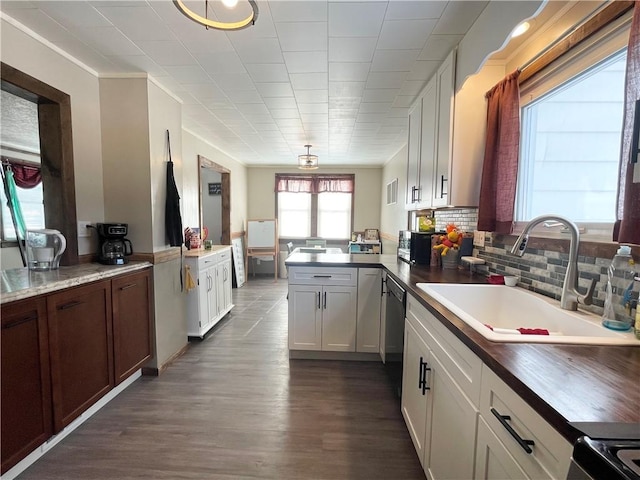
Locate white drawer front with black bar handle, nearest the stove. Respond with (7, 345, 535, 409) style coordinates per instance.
(480, 365, 573, 478)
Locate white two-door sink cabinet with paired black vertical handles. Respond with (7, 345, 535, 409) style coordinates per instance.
(402, 296, 482, 480)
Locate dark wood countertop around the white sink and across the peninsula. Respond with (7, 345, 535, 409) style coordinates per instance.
(286, 253, 640, 443)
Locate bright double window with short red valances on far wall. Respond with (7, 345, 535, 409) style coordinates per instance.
(276, 175, 354, 240)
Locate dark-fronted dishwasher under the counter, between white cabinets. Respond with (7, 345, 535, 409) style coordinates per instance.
(382, 274, 407, 398)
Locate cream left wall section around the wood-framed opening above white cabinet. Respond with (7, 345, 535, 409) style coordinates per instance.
(181, 130, 247, 235)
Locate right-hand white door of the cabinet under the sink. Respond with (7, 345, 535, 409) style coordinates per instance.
(424, 352, 478, 480)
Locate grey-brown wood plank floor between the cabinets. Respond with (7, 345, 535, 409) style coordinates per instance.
(19, 278, 424, 480)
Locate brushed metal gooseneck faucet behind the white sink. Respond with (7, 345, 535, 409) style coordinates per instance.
(511, 215, 596, 310)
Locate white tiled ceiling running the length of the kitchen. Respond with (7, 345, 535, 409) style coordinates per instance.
(0, 0, 516, 166)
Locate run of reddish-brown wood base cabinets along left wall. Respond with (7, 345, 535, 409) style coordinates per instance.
(0, 268, 153, 474)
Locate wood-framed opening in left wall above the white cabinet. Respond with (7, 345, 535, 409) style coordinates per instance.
(198, 155, 231, 245)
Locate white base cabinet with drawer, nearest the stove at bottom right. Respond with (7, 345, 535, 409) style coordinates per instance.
(475, 365, 573, 480)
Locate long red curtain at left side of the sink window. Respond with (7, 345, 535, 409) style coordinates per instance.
(478, 70, 520, 233)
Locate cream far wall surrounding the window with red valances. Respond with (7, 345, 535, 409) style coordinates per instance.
(247, 166, 382, 231)
